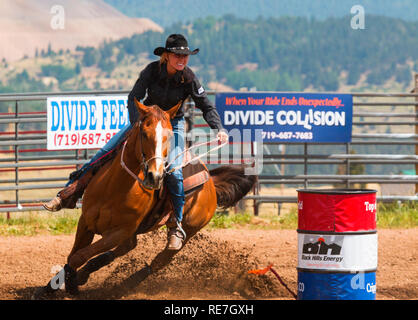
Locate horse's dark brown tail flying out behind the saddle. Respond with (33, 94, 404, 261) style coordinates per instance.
(209, 166, 256, 209)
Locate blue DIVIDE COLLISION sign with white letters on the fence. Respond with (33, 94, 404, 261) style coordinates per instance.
(216, 92, 353, 143)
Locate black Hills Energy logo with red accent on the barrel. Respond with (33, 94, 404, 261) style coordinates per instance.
(301, 235, 344, 262)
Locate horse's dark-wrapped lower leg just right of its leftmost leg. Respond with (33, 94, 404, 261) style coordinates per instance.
(77, 234, 137, 286)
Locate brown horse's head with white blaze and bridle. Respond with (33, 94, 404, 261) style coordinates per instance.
(135, 99, 182, 189)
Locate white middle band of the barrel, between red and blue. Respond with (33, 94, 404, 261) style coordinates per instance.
(298, 233, 377, 271)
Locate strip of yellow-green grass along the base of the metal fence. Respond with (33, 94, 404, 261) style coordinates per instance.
(0, 202, 418, 236)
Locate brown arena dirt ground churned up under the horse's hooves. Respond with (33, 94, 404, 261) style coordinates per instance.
(0, 228, 418, 300)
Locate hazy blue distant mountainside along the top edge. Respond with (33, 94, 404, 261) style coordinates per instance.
(105, 0, 418, 27)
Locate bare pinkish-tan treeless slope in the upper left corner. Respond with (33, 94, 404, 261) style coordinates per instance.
(0, 0, 163, 61)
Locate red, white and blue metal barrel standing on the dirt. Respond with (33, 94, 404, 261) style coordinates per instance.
(297, 189, 377, 300)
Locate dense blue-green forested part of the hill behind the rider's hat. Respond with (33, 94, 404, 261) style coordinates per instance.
(72, 15, 418, 91)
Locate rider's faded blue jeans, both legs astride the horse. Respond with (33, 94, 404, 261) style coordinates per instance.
(66, 117, 185, 222)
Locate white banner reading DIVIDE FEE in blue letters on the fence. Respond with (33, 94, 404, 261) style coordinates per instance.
(47, 95, 129, 150)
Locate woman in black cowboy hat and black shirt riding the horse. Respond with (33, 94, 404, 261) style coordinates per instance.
(43, 34, 228, 250)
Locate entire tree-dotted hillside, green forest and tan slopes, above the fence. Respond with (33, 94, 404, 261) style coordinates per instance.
(0, 15, 418, 92)
